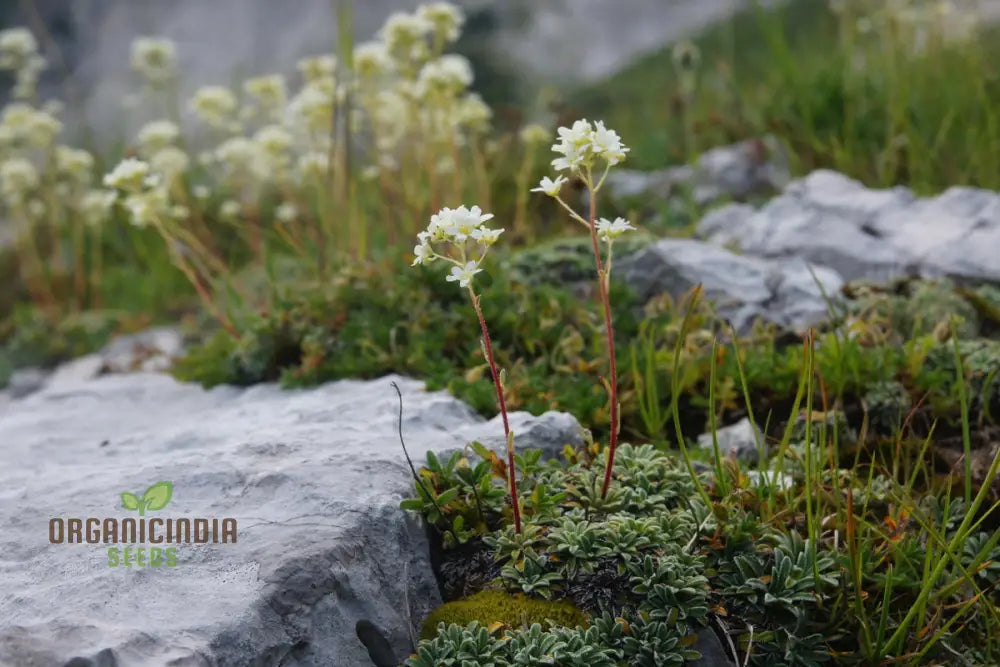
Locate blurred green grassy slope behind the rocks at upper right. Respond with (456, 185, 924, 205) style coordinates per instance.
(567, 0, 1000, 194)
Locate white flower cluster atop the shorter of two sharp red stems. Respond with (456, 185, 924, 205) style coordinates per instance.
(412, 206, 504, 287)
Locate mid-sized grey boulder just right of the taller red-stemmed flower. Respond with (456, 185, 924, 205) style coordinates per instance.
(616, 239, 843, 333)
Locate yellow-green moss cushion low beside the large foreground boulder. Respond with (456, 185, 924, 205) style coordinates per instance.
(420, 590, 589, 639)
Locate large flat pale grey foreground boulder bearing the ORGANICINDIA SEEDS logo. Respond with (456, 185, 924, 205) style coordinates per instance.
(0, 373, 581, 667)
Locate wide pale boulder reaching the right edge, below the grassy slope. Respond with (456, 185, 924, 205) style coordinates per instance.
(698, 170, 1000, 282)
